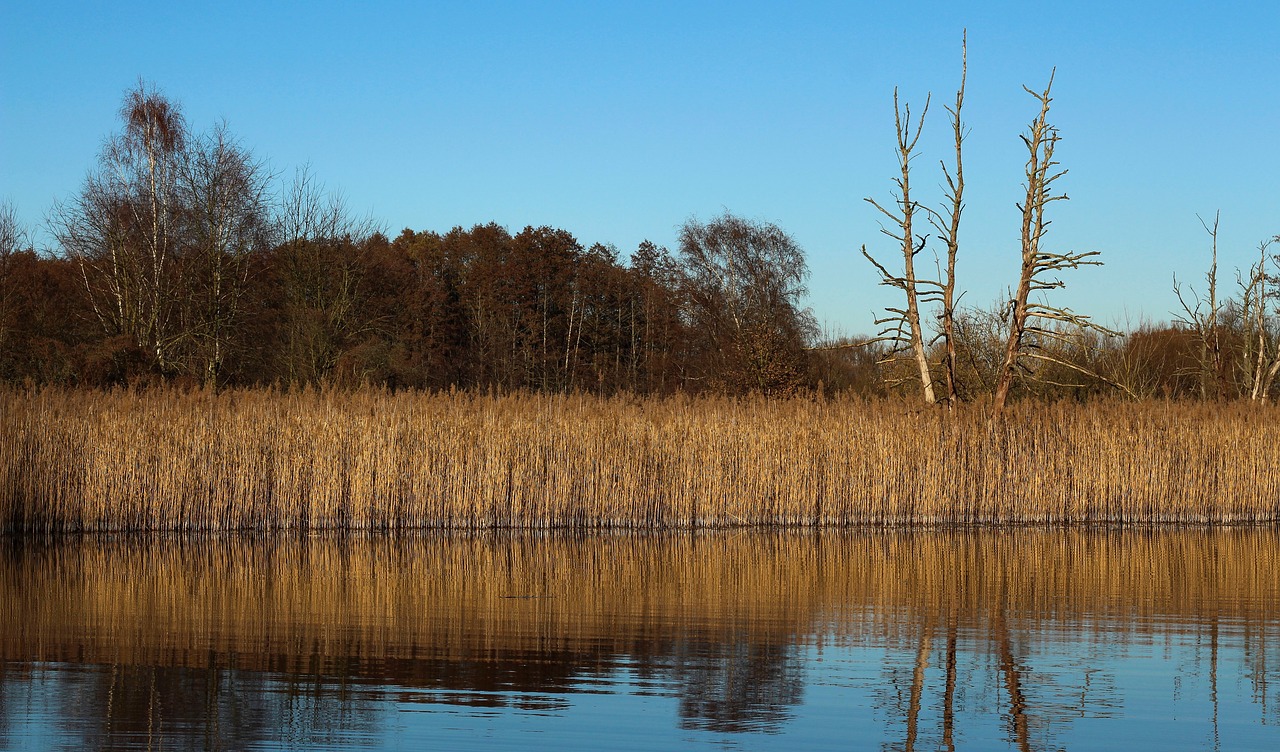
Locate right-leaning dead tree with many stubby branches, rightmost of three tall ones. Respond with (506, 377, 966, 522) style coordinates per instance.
(992, 73, 1116, 416)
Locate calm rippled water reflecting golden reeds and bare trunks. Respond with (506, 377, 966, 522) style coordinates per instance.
(0, 529, 1280, 751)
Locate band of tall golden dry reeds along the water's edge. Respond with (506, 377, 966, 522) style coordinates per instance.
(0, 389, 1280, 532)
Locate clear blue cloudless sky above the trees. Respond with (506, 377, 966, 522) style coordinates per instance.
(0, 0, 1280, 334)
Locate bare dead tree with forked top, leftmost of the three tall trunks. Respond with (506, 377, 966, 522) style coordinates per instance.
(863, 88, 938, 404)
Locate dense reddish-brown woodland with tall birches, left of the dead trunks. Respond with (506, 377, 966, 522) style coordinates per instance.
(0, 86, 814, 394)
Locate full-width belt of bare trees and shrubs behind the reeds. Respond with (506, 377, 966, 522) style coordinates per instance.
(0, 86, 1280, 400)
